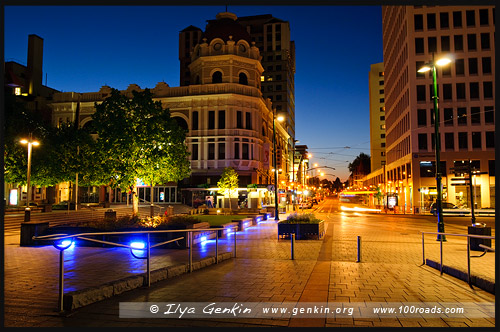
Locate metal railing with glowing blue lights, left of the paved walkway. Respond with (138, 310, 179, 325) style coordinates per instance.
(33, 225, 238, 312)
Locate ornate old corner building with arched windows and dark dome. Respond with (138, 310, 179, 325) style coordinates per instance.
(48, 12, 291, 208)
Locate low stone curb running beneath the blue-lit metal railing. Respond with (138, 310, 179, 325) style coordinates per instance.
(63, 252, 233, 312)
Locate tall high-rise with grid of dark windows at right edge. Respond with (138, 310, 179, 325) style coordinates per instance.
(382, 6, 495, 212)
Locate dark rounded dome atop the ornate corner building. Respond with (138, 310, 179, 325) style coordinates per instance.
(201, 12, 252, 44)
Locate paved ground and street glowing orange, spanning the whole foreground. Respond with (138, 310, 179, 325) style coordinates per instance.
(5, 204, 495, 327)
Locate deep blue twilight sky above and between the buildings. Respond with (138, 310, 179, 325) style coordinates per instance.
(4, 5, 383, 181)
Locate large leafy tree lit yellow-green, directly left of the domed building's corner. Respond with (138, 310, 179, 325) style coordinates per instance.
(92, 89, 190, 213)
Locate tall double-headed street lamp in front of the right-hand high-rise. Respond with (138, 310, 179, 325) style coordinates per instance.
(418, 55, 451, 241)
